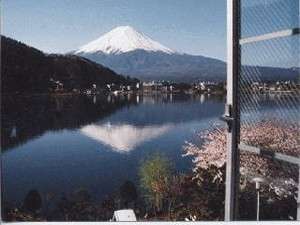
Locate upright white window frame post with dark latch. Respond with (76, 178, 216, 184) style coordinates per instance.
(225, 0, 240, 221)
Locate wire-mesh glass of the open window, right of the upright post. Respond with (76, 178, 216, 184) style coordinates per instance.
(238, 0, 300, 220)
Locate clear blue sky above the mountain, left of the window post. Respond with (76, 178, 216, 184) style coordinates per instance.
(2, 0, 226, 60)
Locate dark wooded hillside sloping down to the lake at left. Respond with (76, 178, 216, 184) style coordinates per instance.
(1, 36, 130, 94)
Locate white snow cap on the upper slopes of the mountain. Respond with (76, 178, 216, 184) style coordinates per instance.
(75, 26, 175, 54)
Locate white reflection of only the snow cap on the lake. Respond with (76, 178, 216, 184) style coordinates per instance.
(80, 124, 173, 153)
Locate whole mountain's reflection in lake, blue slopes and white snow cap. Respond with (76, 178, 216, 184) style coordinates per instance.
(80, 95, 225, 153)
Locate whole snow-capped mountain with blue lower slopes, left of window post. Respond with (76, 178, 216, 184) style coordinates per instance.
(71, 26, 226, 82)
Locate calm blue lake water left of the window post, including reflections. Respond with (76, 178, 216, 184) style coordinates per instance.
(1, 95, 225, 206)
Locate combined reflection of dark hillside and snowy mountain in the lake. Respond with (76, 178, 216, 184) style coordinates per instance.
(1, 95, 221, 151)
